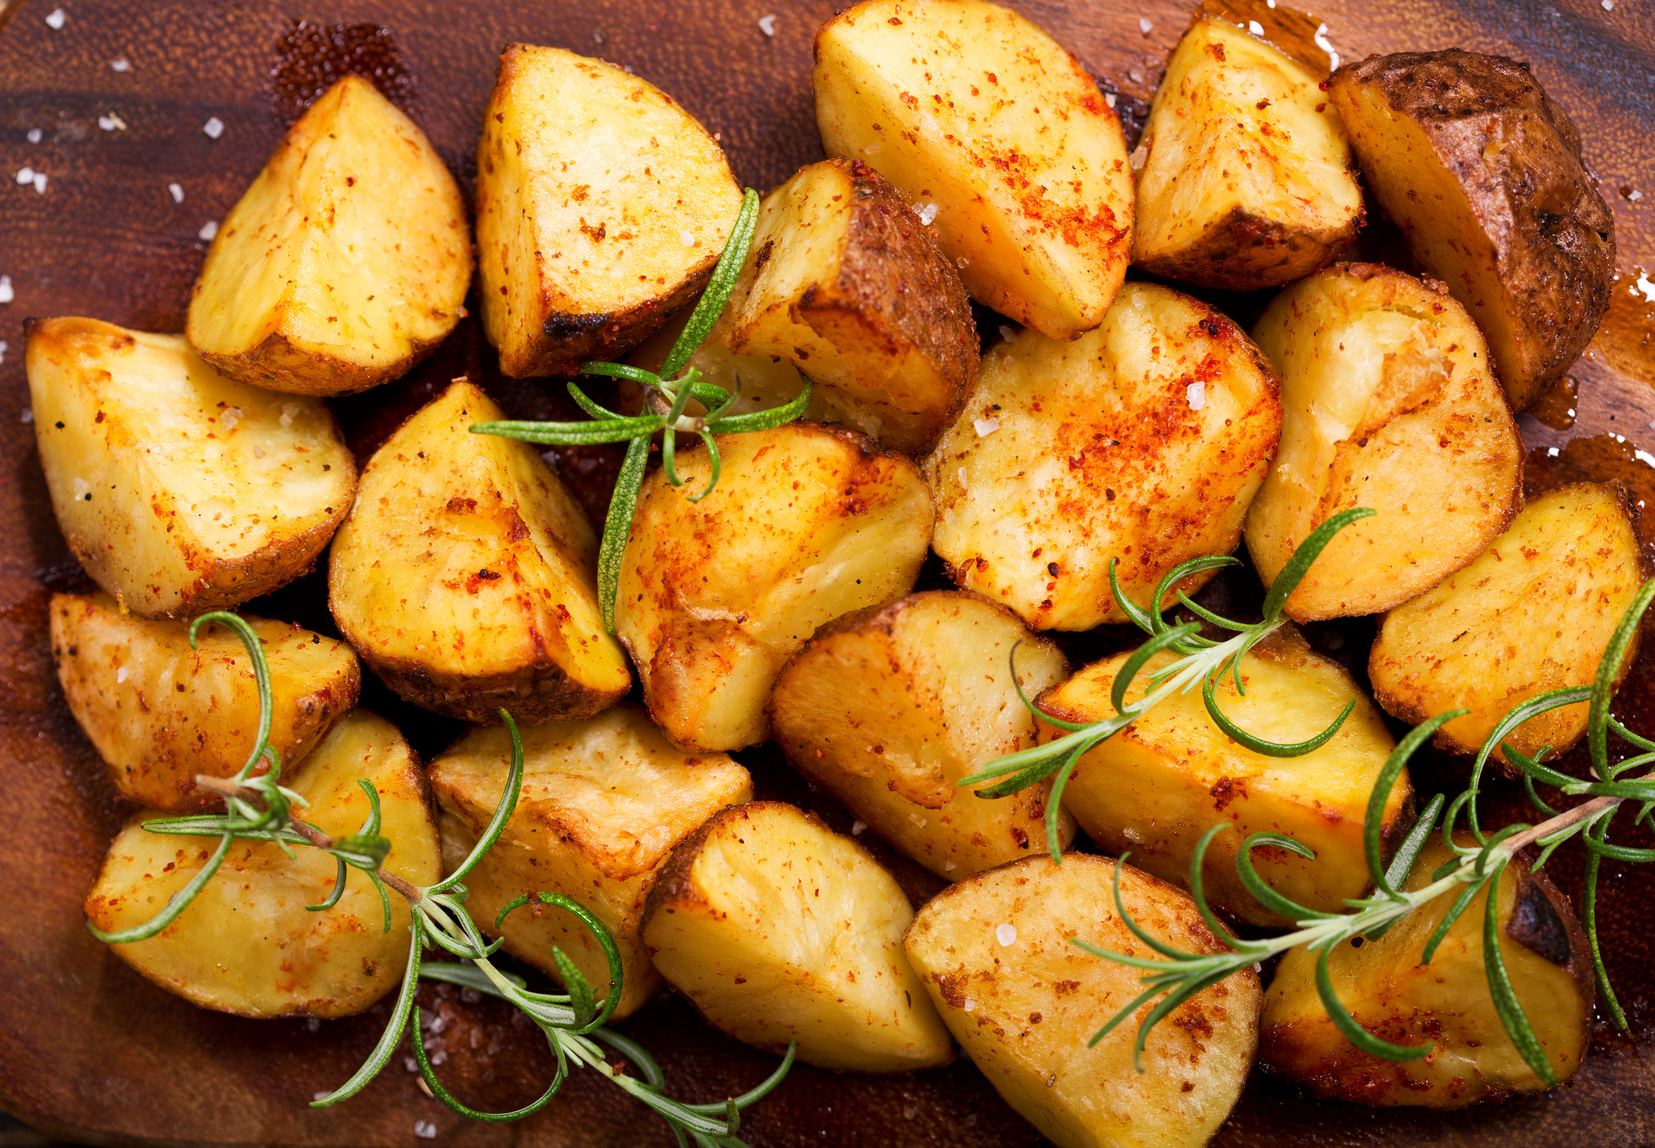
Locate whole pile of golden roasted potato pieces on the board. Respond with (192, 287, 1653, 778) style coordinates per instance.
(26, 0, 1645, 1146)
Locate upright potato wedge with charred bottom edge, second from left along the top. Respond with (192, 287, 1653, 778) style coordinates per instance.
(477, 45, 741, 377)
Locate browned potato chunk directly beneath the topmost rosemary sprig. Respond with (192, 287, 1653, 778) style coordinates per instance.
(616, 423, 933, 749)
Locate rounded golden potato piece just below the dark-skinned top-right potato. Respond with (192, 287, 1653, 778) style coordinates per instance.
(1246, 263, 1523, 622)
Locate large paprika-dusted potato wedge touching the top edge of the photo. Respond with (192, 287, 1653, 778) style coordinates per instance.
(813, 0, 1132, 339)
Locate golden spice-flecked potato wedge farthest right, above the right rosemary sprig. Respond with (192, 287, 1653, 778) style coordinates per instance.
(1367, 483, 1643, 761)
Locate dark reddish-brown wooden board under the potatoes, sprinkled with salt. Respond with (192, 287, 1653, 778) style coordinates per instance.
(0, 0, 1655, 1148)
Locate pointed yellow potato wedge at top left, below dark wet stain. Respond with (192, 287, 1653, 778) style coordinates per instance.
(185, 76, 472, 395)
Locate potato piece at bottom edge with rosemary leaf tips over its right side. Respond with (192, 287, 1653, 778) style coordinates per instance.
(904, 854, 1259, 1148)
